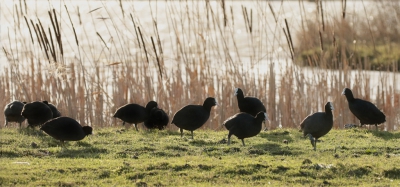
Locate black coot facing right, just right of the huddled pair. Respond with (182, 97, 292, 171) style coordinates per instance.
(171, 97, 217, 139)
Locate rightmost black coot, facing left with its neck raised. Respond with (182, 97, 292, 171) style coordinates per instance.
(342, 88, 386, 130)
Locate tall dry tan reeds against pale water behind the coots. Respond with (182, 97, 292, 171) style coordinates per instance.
(0, 0, 400, 130)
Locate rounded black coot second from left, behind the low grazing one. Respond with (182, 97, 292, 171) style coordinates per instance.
(21, 101, 53, 128)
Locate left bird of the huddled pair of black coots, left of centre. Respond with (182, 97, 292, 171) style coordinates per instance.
(113, 101, 157, 130)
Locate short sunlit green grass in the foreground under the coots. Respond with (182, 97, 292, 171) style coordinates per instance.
(0, 128, 400, 186)
